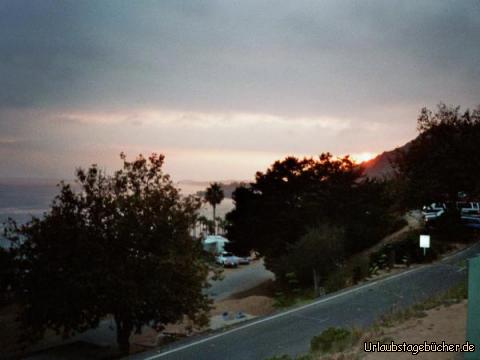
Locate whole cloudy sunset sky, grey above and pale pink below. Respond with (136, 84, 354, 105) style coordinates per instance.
(0, 0, 480, 180)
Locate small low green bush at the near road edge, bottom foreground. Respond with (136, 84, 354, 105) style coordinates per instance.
(310, 327, 360, 353)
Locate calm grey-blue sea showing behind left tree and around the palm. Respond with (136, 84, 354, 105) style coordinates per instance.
(0, 182, 233, 247)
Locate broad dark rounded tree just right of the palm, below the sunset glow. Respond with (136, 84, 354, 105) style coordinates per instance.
(227, 153, 389, 280)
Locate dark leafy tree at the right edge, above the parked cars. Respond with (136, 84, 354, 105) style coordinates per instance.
(396, 103, 480, 207)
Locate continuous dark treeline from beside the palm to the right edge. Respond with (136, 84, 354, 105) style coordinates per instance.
(227, 104, 480, 285)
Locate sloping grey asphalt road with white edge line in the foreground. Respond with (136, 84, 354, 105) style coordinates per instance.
(130, 243, 480, 360)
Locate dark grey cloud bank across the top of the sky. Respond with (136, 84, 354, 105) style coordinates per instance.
(0, 0, 480, 115)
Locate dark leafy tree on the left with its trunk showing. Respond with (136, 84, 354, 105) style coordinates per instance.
(8, 154, 211, 352)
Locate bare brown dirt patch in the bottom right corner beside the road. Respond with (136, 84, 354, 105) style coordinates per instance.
(362, 300, 467, 360)
